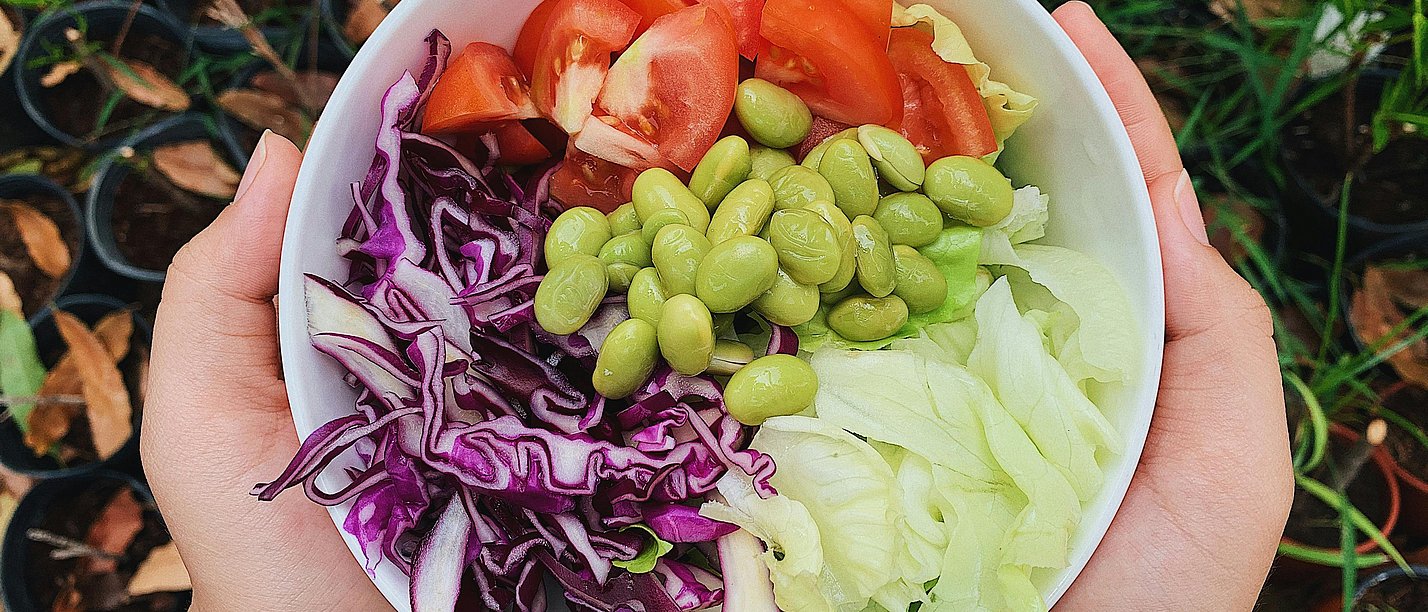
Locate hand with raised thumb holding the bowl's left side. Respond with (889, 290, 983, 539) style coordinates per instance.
(140, 133, 390, 611)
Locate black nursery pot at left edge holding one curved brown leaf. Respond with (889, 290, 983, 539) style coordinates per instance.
(0, 174, 86, 317)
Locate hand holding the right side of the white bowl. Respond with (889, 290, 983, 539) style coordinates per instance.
(1054, 1, 1294, 611)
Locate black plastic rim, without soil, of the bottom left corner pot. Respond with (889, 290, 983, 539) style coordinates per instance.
(0, 471, 191, 612)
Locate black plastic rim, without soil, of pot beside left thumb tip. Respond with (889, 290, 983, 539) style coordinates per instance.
(84, 113, 240, 282)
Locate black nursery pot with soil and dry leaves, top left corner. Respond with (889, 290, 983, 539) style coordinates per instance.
(13, 0, 188, 151)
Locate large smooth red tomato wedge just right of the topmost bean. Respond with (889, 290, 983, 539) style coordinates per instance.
(755, 0, 902, 126)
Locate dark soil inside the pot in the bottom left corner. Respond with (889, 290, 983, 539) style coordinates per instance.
(27, 481, 181, 612)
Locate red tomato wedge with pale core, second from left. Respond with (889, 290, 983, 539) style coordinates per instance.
(526, 0, 640, 134)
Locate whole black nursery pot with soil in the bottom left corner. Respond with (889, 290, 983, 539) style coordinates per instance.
(0, 471, 191, 612)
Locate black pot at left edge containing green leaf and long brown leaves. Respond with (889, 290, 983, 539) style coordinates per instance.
(0, 294, 154, 479)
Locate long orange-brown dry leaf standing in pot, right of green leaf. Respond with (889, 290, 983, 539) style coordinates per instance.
(54, 311, 133, 459)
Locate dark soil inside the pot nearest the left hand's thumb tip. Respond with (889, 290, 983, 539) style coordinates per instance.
(111, 161, 227, 270)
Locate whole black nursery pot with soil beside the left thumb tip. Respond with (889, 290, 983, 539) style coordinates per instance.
(84, 114, 233, 282)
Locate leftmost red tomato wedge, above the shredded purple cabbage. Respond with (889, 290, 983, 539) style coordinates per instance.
(421, 43, 538, 134)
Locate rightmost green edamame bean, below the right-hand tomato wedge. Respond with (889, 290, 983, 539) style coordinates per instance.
(922, 155, 1015, 227)
